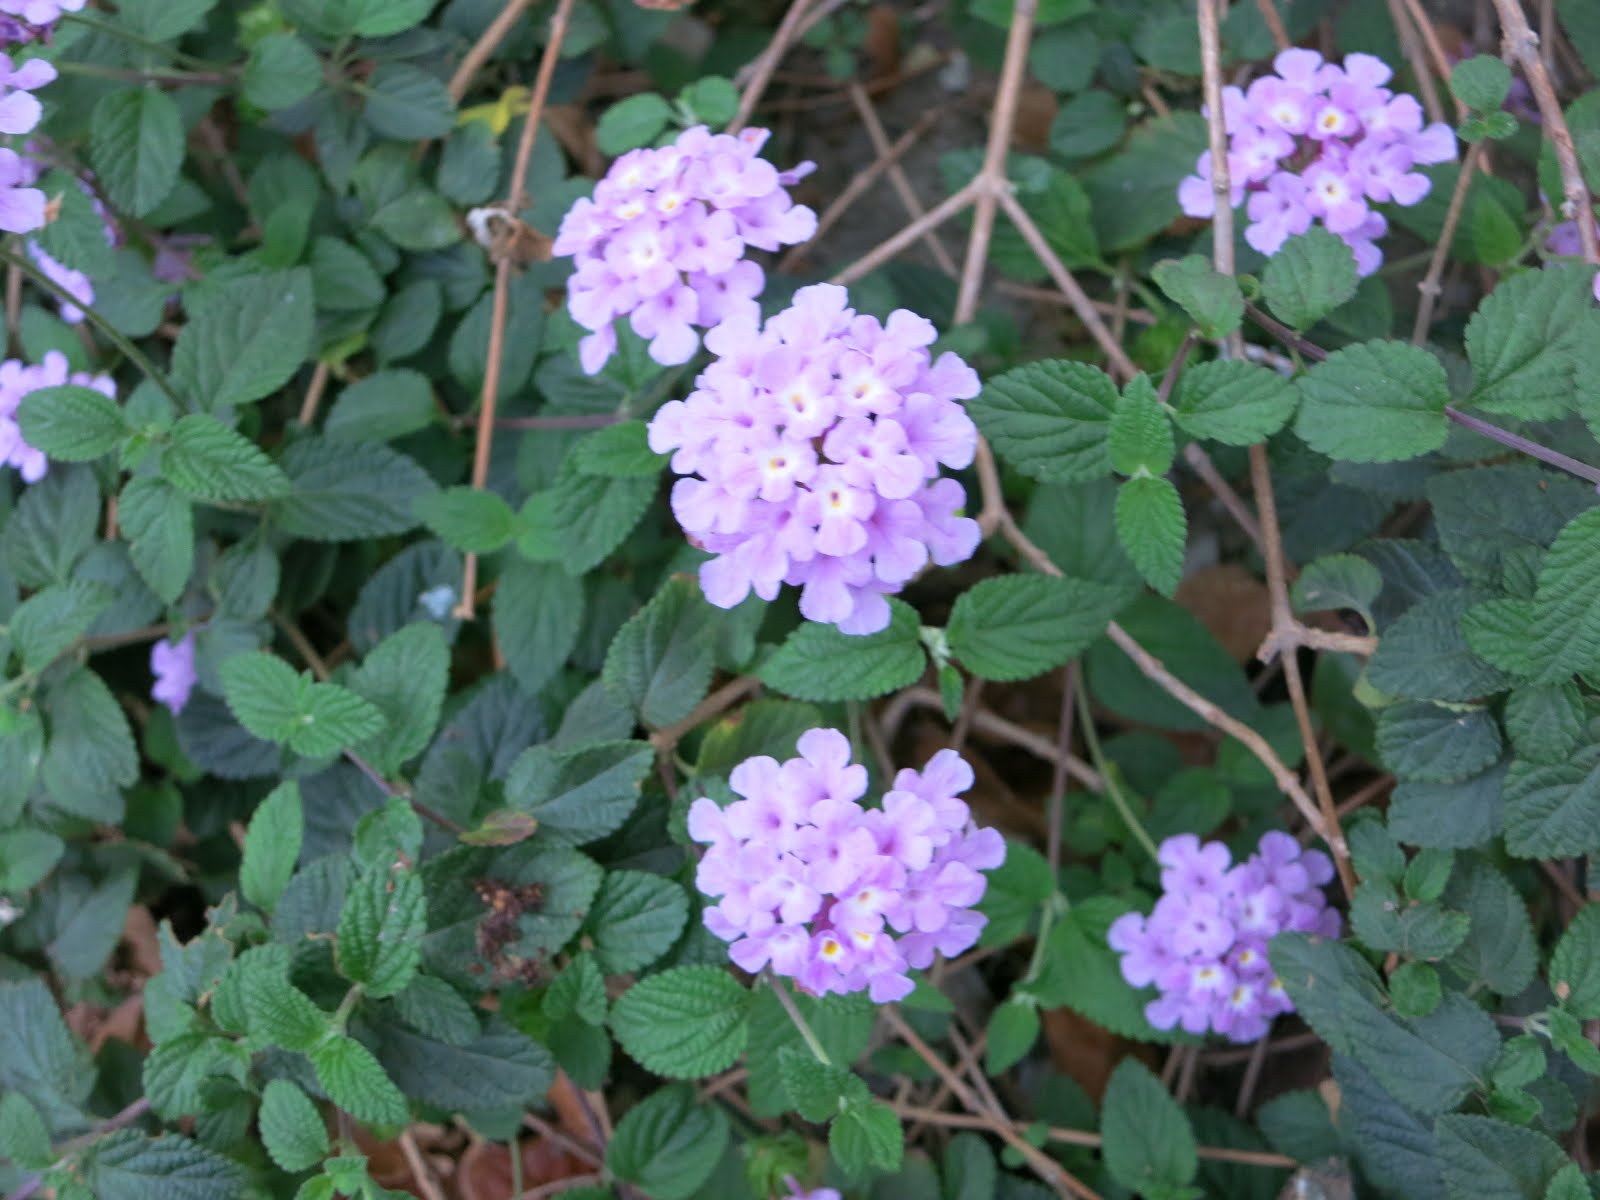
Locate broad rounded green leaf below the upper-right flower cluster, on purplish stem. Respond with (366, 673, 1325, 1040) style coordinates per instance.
(1294, 341, 1450, 462)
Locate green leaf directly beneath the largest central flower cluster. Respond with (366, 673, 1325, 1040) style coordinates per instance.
(755, 600, 926, 701)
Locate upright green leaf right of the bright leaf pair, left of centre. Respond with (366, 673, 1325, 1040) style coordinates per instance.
(350, 621, 450, 771)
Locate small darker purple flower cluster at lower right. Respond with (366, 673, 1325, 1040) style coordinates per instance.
(1107, 832, 1339, 1042)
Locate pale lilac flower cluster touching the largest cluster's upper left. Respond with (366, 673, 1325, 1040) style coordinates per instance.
(554, 125, 816, 374)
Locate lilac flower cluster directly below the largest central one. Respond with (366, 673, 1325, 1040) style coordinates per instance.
(688, 730, 1005, 1003)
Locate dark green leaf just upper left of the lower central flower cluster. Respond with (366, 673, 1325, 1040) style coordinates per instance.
(506, 741, 654, 845)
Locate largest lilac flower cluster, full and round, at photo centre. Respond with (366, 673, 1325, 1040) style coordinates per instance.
(650, 283, 979, 634)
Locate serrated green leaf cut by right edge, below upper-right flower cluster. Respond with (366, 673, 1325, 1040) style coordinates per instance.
(1466, 262, 1600, 421)
